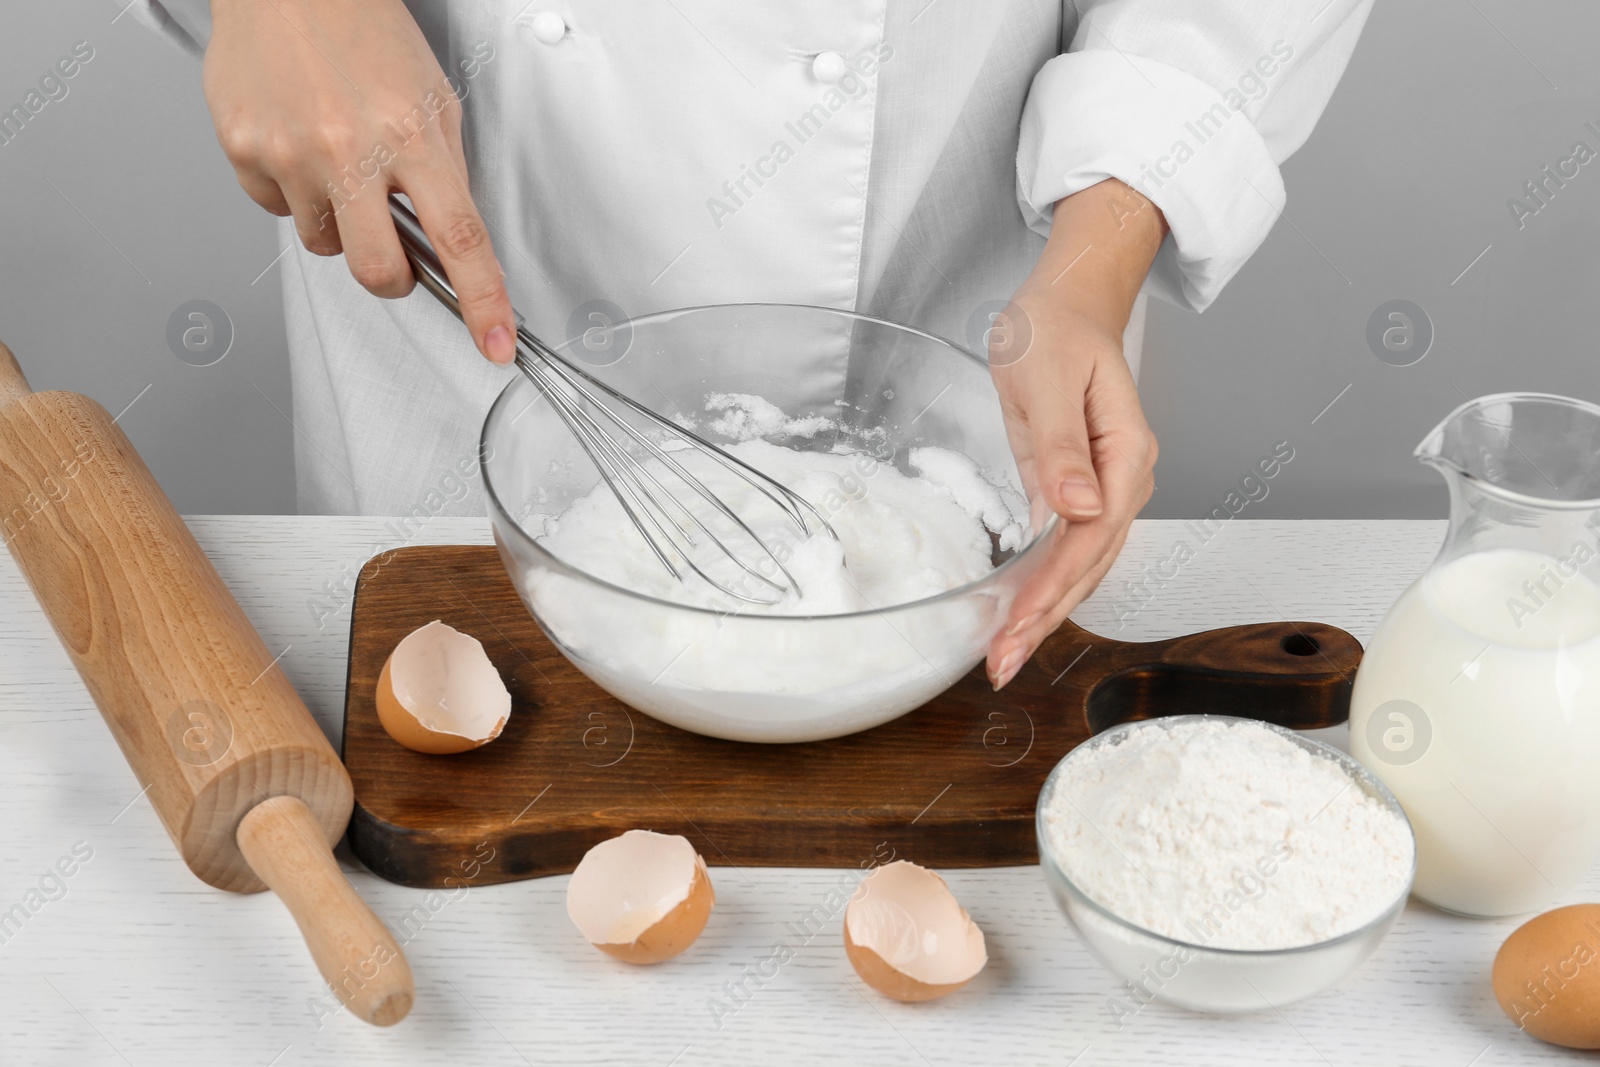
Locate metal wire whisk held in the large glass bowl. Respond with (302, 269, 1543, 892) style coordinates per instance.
(389, 195, 838, 605)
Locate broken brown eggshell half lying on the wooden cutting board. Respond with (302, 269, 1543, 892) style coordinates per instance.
(378, 619, 510, 755)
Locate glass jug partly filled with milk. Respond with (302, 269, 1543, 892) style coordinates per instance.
(1350, 394, 1600, 915)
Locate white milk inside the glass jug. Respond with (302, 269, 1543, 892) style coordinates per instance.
(1350, 549, 1600, 915)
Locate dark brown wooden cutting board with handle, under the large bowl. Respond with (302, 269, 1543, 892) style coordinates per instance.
(342, 545, 1362, 888)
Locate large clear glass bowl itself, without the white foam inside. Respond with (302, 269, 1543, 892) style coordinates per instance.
(482, 304, 1056, 742)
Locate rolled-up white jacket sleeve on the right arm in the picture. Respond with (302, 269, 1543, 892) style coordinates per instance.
(1018, 0, 1373, 310)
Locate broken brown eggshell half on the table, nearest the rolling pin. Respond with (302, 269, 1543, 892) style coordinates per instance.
(566, 830, 717, 963)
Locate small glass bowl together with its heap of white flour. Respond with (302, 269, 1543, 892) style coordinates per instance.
(1035, 715, 1416, 1029)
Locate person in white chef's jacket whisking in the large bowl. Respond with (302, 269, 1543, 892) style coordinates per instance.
(131, 0, 1371, 688)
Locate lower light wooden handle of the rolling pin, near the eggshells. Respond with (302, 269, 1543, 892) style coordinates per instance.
(238, 797, 414, 1027)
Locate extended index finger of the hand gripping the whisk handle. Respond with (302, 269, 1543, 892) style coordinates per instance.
(400, 163, 517, 363)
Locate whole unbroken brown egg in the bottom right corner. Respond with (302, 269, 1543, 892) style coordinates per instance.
(1491, 904, 1600, 1048)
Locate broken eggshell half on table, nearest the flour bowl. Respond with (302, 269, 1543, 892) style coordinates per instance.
(845, 859, 989, 1001)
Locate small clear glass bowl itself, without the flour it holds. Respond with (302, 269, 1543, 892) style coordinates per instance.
(1034, 715, 1416, 1013)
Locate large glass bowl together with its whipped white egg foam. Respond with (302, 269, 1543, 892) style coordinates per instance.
(482, 304, 1056, 742)
